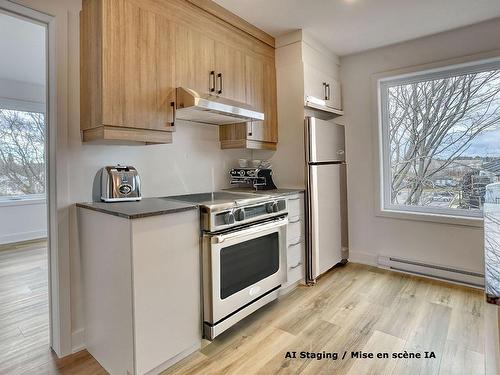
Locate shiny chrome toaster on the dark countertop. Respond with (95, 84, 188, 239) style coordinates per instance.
(101, 164, 141, 202)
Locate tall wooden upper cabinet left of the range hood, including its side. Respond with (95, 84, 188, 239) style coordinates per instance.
(80, 0, 175, 143)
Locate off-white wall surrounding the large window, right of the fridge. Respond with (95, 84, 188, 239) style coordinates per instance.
(341, 19, 500, 273)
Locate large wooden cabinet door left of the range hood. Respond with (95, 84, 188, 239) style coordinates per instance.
(102, 0, 175, 130)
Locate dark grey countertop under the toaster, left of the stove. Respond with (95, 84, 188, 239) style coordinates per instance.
(76, 198, 198, 219)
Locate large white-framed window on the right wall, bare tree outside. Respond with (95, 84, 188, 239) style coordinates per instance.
(379, 61, 500, 217)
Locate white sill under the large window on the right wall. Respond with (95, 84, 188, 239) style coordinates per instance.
(376, 209, 483, 228)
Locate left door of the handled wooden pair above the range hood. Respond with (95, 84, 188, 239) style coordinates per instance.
(176, 25, 215, 93)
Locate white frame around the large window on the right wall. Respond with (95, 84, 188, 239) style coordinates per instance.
(376, 57, 500, 226)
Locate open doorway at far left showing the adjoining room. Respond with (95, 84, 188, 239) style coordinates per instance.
(0, 3, 53, 373)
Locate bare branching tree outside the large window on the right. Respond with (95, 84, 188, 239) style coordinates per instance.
(388, 71, 500, 205)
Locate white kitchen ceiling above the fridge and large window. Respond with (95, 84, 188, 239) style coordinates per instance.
(215, 0, 500, 56)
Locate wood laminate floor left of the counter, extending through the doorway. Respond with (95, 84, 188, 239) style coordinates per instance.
(0, 241, 106, 375)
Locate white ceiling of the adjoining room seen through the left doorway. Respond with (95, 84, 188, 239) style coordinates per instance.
(0, 13, 45, 85)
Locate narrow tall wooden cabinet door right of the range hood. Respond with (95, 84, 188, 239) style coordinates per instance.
(245, 55, 278, 143)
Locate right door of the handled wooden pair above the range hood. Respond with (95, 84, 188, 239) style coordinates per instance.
(215, 42, 246, 102)
